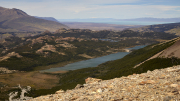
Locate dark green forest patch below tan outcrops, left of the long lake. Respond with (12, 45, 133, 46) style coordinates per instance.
(0, 52, 84, 71)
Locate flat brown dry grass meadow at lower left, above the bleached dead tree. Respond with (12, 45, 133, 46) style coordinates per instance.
(0, 72, 59, 89)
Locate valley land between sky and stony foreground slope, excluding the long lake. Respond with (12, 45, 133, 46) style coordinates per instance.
(0, 7, 180, 100)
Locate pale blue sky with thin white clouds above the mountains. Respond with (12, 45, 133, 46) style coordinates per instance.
(0, 0, 180, 19)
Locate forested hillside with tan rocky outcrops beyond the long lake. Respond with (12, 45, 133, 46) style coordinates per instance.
(0, 29, 165, 71)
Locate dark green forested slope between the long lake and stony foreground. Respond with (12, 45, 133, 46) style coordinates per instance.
(26, 38, 180, 97)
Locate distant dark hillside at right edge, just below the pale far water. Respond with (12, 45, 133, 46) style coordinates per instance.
(130, 23, 180, 35)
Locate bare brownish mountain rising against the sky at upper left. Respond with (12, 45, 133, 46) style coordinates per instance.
(0, 7, 68, 32)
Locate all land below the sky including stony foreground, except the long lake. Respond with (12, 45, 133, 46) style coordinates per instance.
(0, 7, 180, 101)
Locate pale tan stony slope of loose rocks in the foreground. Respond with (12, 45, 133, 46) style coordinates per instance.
(29, 66, 180, 101)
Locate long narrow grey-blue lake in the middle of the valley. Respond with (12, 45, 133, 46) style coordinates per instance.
(41, 45, 146, 72)
